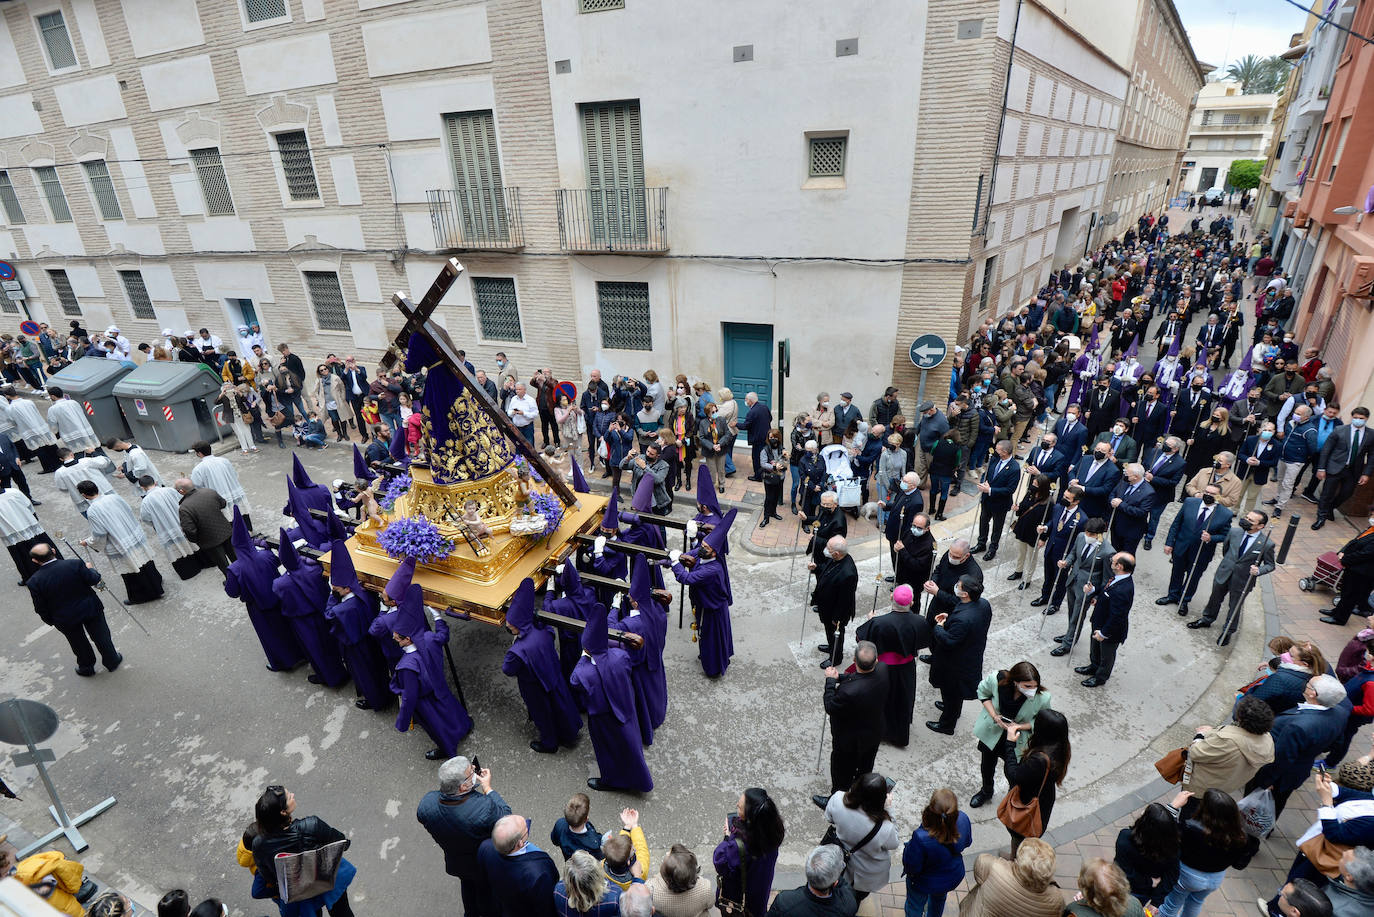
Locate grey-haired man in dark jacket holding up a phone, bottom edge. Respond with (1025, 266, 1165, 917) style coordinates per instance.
(415, 756, 511, 917)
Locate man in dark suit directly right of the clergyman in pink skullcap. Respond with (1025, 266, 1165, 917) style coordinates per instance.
(926, 575, 992, 736)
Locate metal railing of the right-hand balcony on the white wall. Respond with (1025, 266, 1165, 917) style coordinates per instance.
(558, 187, 668, 252)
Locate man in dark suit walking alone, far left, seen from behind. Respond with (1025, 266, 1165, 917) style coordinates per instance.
(27, 543, 124, 678)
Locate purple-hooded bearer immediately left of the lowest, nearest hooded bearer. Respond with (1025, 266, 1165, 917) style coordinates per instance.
(502, 577, 583, 755)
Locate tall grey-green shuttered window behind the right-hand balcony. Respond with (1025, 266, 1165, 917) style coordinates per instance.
(581, 99, 649, 245)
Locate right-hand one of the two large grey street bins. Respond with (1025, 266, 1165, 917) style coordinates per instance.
(112, 360, 229, 452)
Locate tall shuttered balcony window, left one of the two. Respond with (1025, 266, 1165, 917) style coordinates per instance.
(444, 110, 510, 245)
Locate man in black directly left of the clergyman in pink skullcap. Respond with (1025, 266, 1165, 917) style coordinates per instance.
(812, 641, 888, 806)
